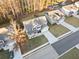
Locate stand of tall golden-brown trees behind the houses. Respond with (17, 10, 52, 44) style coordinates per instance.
(0, 0, 64, 19)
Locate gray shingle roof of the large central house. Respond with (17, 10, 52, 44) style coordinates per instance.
(25, 17, 46, 35)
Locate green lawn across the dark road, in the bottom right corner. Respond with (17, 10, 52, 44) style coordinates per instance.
(59, 48, 79, 59)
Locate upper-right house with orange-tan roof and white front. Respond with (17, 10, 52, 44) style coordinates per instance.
(62, 4, 78, 16)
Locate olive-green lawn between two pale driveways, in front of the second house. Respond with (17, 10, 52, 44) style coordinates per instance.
(49, 24, 69, 37)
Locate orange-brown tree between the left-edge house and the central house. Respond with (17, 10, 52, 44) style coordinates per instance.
(8, 16, 28, 48)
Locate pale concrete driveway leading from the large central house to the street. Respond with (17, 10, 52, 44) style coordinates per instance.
(43, 31, 58, 44)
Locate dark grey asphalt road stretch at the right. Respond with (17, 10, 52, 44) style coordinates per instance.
(52, 31, 79, 55)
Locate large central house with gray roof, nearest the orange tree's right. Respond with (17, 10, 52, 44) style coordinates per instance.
(23, 16, 48, 39)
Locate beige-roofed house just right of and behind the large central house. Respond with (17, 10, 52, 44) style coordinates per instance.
(45, 10, 65, 24)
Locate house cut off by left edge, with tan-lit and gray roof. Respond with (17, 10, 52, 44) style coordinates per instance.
(0, 28, 16, 51)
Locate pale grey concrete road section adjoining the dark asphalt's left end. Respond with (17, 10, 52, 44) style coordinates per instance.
(23, 45, 58, 59)
